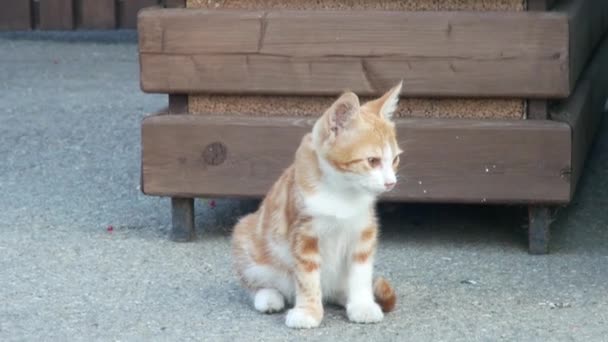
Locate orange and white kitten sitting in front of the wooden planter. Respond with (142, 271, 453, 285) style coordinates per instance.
(232, 83, 401, 328)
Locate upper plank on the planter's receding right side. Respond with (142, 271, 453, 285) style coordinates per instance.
(555, 0, 608, 89)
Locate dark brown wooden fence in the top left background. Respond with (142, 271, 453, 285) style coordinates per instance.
(0, 0, 186, 31)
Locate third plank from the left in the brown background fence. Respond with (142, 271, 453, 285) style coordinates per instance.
(79, 0, 116, 29)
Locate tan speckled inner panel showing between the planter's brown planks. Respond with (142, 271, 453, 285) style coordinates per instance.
(187, 0, 526, 119)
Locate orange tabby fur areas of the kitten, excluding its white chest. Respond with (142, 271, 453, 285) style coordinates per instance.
(232, 81, 401, 328)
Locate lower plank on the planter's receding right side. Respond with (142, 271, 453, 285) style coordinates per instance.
(551, 37, 608, 200)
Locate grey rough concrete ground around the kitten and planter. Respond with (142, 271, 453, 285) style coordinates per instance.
(0, 32, 608, 341)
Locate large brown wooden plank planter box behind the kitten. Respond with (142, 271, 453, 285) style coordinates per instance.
(138, 0, 608, 254)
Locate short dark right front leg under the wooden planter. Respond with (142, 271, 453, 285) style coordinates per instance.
(528, 205, 552, 254)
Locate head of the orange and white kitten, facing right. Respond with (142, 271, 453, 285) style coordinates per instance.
(313, 83, 402, 195)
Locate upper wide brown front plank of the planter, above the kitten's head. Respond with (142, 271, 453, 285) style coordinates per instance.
(138, 9, 570, 98)
